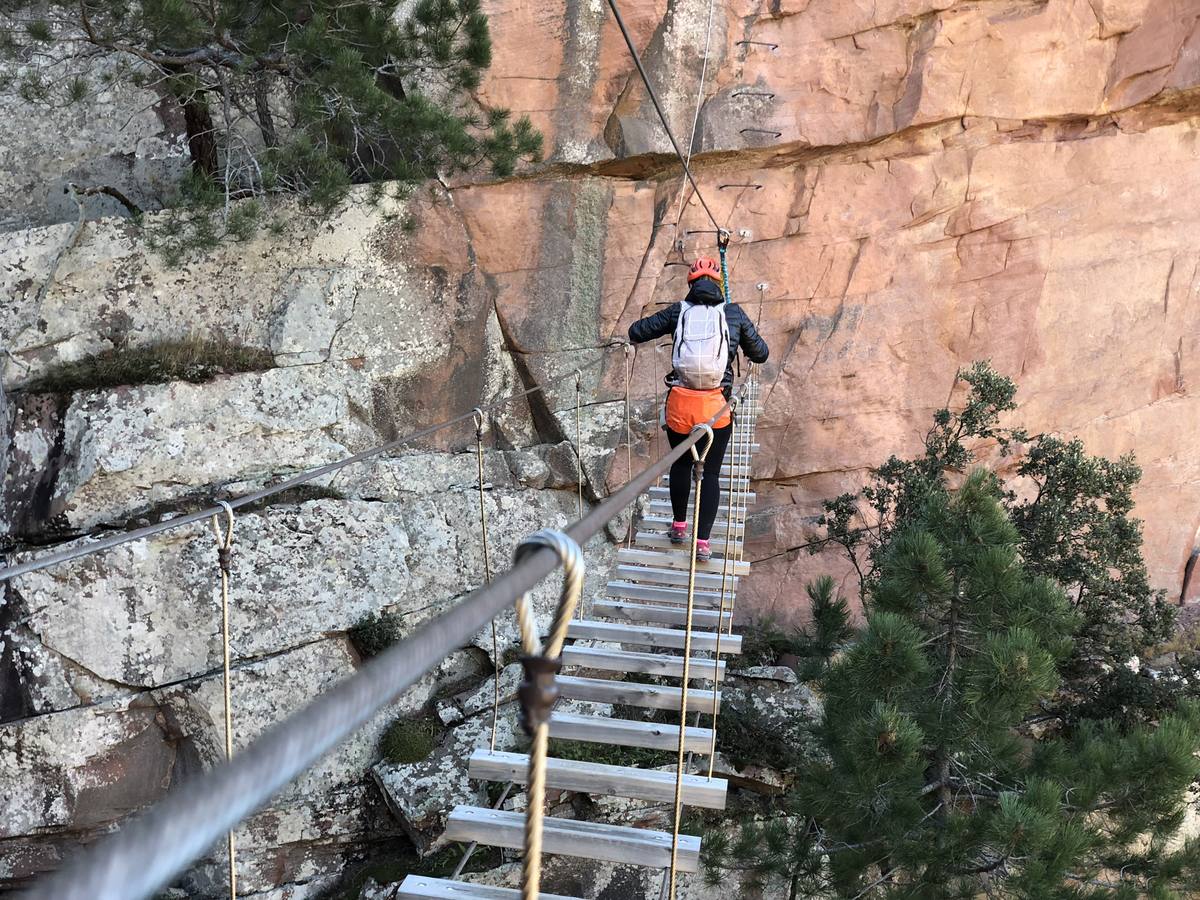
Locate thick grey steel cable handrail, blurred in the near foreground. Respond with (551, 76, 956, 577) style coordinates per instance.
(25, 386, 730, 900)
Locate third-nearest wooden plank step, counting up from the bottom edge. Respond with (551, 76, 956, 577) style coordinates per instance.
(468, 748, 726, 809)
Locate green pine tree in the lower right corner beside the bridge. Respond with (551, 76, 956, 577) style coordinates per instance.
(706, 472, 1200, 900)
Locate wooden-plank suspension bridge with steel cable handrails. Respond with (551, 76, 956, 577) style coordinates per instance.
(0, 0, 768, 900)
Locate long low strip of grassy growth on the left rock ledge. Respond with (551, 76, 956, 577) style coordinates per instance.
(26, 337, 274, 394)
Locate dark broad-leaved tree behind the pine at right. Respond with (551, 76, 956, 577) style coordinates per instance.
(814, 362, 1175, 706)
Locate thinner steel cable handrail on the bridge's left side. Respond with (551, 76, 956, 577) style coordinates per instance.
(0, 341, 625, 582)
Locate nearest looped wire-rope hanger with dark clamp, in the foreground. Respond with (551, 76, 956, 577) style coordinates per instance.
(512, 529, 584, 900)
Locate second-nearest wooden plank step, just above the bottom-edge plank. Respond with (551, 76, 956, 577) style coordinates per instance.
(446, 806, 700, 872)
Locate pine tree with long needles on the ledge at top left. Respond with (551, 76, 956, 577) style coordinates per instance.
(0, 0, 542, 262)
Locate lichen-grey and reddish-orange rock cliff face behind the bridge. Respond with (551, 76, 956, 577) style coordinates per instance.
(0, 0, 1200, 896)
